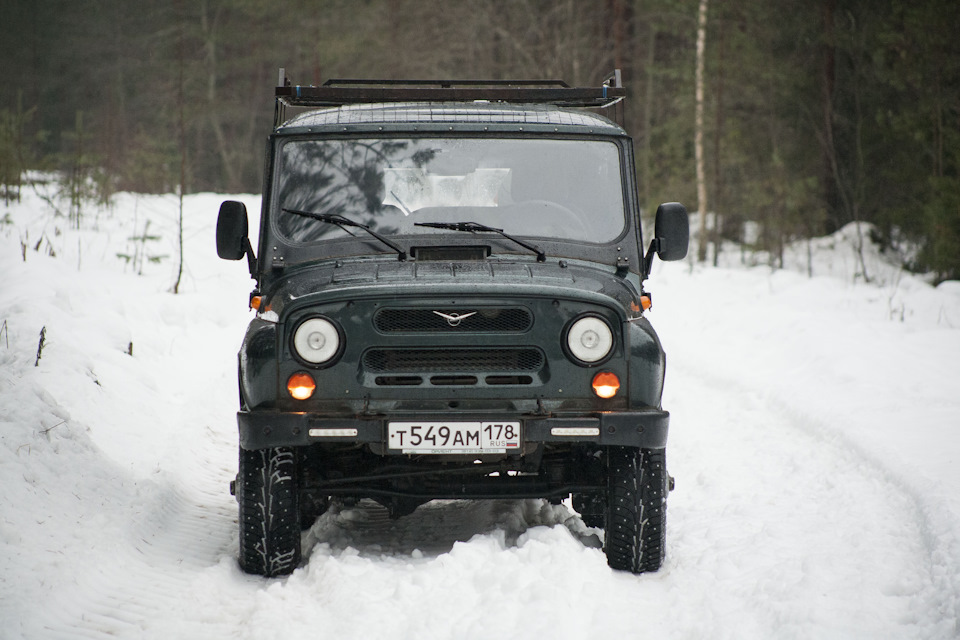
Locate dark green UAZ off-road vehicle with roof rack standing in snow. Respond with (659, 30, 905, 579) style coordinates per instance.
(217, 70, 688, 576)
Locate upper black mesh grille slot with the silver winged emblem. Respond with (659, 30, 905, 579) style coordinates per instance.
(373, 307, 533, 333)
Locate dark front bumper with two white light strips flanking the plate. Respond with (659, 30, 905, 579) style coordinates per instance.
(237, 409, 670, 453)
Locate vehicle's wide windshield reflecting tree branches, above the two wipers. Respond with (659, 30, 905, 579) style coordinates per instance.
(274, 138, 625, 243)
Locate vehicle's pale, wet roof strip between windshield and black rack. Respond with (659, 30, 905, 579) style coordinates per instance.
(277, 102, 626, 135)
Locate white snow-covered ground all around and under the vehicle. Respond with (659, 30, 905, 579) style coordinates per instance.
(0, 186, 960, 640)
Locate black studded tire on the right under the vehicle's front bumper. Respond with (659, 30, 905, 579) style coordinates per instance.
(604, 447, 669, 573)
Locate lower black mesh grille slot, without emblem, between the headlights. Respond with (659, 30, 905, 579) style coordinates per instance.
(363, 347, 543, 373)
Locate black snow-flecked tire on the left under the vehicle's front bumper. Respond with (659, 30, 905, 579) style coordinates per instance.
(236, 447, 300, 577)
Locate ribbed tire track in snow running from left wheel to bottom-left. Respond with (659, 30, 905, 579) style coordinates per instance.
(25, 440, 236, 638)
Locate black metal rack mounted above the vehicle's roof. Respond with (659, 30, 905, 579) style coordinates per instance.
(274, 68, 626, 126)
